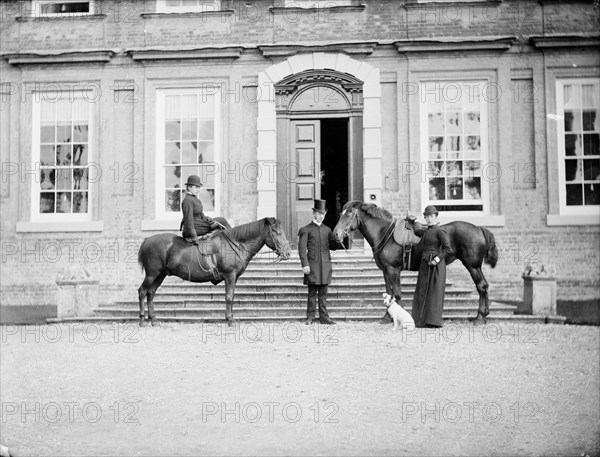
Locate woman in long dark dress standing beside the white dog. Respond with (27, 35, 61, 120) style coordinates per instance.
(410, 205, 452, 327)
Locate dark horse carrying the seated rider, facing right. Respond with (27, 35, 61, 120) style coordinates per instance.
(138, 218, 291, 326)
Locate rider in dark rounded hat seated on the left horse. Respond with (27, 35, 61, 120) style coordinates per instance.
(180, 175, 229, 244)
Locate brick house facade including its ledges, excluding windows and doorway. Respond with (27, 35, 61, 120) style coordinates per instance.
(0, 0, 600, 316)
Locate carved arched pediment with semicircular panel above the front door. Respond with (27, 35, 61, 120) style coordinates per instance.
(275, 70, 363, 115)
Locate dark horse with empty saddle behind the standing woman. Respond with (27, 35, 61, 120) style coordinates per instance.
(333, 201, 498, 322)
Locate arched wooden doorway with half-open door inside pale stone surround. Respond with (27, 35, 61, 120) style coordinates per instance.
(275, 70, 363, 240)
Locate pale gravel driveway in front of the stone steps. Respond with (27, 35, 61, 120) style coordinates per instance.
(0, 322, 600, 456)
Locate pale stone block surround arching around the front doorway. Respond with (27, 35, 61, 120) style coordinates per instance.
(256, 52, 383, 248)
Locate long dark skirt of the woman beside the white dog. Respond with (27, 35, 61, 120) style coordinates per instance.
(412, 256, 446, 327)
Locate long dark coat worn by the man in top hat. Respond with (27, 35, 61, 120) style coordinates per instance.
(298, 222, 343, 285)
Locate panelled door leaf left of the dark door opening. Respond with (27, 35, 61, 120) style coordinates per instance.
(288, 120, 321, 236)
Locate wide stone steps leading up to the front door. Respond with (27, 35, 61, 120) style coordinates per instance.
(51, 251, 568, 322)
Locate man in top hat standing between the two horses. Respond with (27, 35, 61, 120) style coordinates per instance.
(298, 200, 343, 324)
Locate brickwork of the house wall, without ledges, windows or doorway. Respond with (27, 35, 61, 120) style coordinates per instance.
(0, 0, 600, 305)
